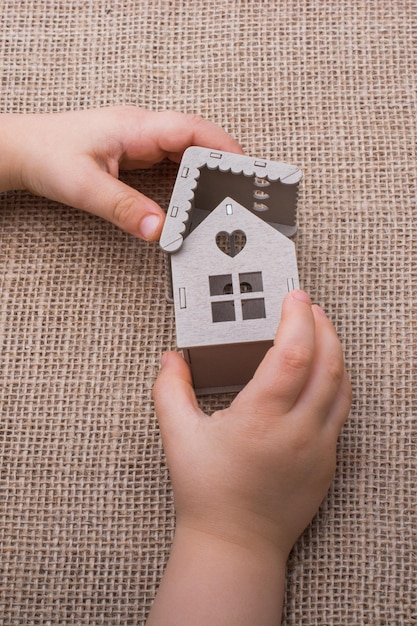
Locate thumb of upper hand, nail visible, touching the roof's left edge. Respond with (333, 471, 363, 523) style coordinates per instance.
(60, 159, 165, 241)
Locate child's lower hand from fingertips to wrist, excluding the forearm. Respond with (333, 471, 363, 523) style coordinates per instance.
(154, 291, 351, 559)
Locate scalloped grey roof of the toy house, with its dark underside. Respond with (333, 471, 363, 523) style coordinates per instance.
(160, 146, 302, 252)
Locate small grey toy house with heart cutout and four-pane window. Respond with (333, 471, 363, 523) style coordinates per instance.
(160, 147, 301, 393)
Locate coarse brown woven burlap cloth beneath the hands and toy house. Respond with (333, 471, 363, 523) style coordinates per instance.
(0, 0, 417, 626)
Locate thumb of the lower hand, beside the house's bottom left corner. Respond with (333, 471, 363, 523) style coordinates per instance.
(153, 352, 202, 445)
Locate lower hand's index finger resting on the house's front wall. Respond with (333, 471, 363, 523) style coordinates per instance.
(234, 290, 316, 415)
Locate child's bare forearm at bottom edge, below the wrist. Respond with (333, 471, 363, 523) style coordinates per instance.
(147, 528, 285, 626)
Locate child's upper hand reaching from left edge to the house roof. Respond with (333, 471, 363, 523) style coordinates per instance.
(0, 107, 242, 240)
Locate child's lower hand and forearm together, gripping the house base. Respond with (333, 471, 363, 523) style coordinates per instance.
(147, 291, 351, 626)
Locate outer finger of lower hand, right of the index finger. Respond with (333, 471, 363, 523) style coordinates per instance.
(298, 305, 347, 423)
